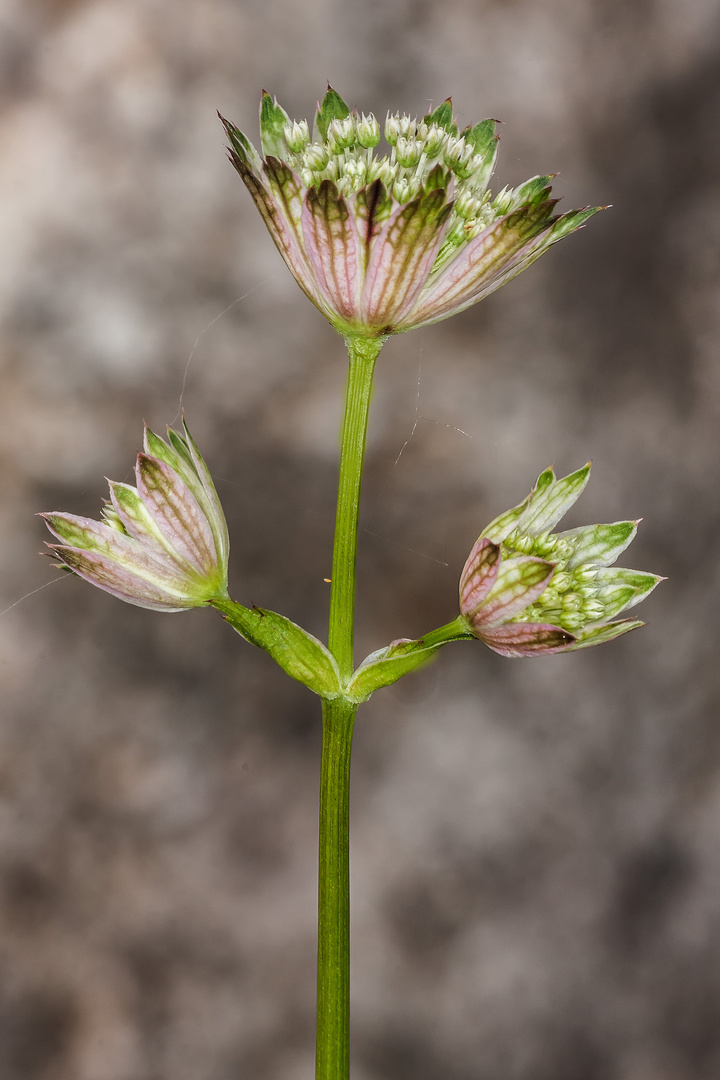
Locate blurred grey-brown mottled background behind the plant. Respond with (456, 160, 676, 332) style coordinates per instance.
(0, 0, 720, 1080)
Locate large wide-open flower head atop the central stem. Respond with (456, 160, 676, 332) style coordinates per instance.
(220, 86, 602, 337)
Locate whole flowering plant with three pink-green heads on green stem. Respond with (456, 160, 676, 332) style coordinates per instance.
(43, 89, 661, 1080)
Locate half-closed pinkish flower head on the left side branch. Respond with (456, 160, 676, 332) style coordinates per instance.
(41, 420, 229, 611)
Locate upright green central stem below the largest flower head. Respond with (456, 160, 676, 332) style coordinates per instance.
(315, 338, 382, 1080)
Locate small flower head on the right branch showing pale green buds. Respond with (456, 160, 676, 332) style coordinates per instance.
(460, 464, 664, 657)
